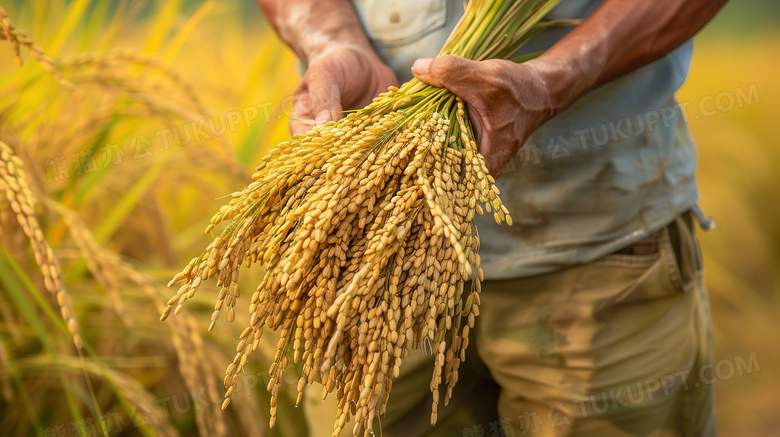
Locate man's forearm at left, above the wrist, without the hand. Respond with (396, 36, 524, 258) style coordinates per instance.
(257, 0, 371, 62)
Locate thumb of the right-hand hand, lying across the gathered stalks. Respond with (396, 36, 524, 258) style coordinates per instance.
(412, 55, 479, 98)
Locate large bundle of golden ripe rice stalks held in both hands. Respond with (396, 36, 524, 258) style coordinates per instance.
(162, 0, 558, 436)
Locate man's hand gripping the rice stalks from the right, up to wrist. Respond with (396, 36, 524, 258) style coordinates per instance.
(412, 55, 561, 177)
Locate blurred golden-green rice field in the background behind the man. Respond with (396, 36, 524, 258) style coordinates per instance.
(0, 0, 780, 437)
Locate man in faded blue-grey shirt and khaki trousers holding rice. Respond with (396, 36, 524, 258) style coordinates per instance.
(258, 0, 725, 437)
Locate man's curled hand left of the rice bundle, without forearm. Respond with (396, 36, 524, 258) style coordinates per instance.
(290, 43, 398, 135)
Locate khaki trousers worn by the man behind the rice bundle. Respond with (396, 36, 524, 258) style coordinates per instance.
(304, 214, 716, 437)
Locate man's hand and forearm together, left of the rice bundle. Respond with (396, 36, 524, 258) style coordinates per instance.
(257, 0, 398, 135)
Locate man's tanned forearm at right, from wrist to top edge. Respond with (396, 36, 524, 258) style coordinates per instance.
(536, 0, 726, 109)
